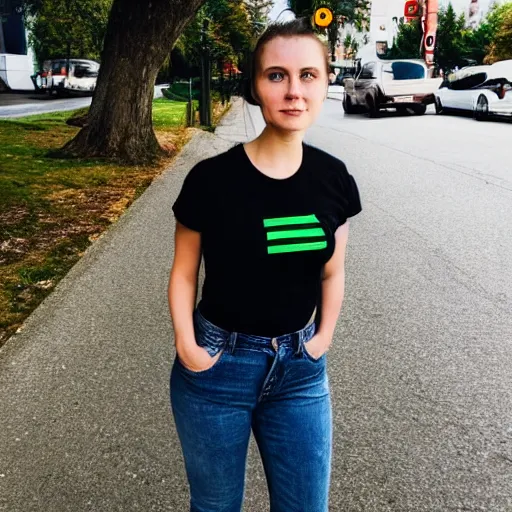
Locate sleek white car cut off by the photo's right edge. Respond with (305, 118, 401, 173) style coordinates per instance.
(435, 60, 512, 121)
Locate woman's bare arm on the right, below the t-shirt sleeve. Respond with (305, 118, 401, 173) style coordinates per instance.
(308, 221, 349, 359)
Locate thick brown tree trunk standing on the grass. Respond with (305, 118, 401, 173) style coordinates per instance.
(62, 0, 204, 164)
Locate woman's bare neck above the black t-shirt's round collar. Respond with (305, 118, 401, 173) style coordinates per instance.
(245, 125, 304, 179)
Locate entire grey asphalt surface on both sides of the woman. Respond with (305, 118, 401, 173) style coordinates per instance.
(0, 100, 512, 512)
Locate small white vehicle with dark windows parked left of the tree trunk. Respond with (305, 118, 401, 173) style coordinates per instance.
(32, 59, 100, 95)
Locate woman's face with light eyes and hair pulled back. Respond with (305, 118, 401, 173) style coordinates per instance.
(254, 36, 328, 136)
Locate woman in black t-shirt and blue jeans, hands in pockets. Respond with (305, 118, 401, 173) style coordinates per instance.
(169, 20, 361, 512)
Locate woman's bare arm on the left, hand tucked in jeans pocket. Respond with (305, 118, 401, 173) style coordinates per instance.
(168, 222, 217, 371)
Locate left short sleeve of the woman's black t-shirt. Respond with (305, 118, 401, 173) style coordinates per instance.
(172, 162, 208, 233)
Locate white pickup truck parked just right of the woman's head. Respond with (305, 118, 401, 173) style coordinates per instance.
(343, 59, 442, 117)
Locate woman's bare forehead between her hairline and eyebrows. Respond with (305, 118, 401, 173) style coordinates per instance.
(260, 36, 325, 69)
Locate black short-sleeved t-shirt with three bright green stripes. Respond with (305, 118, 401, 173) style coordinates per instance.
(173, 144, 361, 337)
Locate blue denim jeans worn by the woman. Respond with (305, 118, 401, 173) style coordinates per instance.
(170, 310, 332, 512)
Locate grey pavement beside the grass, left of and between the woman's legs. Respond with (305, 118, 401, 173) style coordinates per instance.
(0, 100, 267, 512)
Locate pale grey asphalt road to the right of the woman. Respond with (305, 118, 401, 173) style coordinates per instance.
(308, 101, 512, 512)
